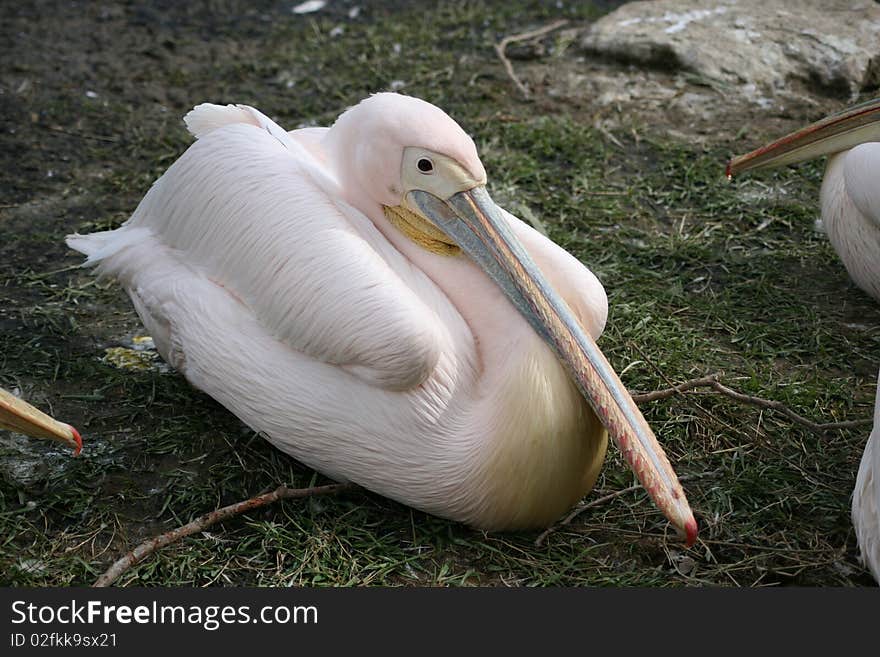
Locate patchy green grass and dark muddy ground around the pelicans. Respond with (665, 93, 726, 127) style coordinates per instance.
(0, 1, 880, 586)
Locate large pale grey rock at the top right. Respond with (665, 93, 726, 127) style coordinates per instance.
(581, 0, 880, 104)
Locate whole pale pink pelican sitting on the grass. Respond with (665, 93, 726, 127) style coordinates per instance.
(67, 93, 697, 545)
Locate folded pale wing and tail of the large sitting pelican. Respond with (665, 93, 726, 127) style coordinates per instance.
(68, 108, 442, 390)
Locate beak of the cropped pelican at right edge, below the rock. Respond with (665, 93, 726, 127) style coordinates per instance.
(727, 98, 880, 178)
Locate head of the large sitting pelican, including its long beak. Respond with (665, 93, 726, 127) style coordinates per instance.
(328, 93, 697, 545)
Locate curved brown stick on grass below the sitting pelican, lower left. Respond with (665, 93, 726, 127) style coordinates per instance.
(93, 484, 356, 587)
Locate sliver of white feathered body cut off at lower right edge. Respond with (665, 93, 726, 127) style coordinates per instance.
(852, 375, 880, 582)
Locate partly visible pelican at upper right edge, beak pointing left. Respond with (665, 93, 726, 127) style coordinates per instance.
(727, 98, 880, 301)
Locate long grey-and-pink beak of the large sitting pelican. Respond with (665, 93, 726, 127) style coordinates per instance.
(406, 186, 697, 546)
